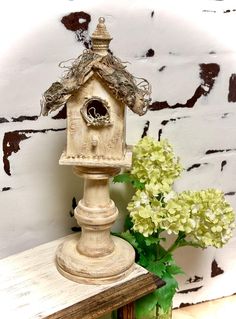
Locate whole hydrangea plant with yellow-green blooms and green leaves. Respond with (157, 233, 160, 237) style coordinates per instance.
(113, 137, 235, 319)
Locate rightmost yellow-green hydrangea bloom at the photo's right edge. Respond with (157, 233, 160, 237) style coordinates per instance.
(178, 189, 235, 248)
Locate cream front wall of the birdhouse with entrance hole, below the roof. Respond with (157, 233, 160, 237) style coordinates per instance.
(64, 74, 126, 162)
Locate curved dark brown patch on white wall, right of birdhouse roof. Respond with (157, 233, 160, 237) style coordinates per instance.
(149, 63, 220, 111)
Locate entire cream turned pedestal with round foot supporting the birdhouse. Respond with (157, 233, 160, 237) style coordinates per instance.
(56, 166, 135, 284)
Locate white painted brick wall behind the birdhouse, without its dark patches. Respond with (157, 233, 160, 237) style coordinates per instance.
(0, 0, 236, 312)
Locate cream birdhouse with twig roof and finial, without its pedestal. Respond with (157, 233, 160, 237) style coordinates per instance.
(42, 18, 150, 167)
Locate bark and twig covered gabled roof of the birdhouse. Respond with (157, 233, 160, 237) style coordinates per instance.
(41, 50, 151, 115)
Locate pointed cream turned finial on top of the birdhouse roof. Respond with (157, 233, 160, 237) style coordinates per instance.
(91, 17, 112, 55)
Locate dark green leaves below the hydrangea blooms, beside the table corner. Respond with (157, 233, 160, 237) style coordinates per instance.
(120, 229, 183, 319)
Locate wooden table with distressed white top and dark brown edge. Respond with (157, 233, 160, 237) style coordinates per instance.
(0, 235, 164, 319)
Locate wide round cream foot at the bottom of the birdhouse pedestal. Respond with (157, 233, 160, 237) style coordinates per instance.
(56, 234, 135, 284)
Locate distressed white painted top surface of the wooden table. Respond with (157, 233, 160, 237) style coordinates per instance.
(0, 235, 147, 319)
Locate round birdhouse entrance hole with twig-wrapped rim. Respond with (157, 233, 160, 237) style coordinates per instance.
(81, 97, 111, 126)
